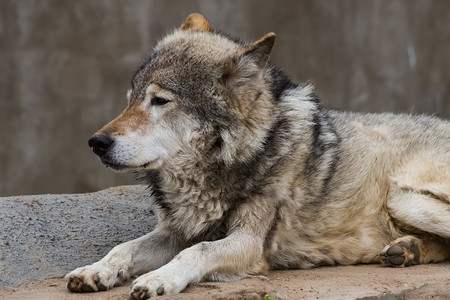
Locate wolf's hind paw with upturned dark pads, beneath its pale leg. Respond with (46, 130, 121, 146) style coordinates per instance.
(380, 237, 420, 267)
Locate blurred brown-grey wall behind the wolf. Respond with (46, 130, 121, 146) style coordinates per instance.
(0, 0, 450, 196)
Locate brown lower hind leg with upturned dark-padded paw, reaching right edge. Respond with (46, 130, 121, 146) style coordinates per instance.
(380, 235, 450, 267)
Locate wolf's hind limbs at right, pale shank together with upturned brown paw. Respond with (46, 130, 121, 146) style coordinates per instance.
(380, 185, 450, 267)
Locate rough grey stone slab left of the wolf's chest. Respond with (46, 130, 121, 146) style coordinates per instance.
(0, 185, 155, 287)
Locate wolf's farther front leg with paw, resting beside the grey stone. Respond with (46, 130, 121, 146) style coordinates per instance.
(66, 229, 181, 293)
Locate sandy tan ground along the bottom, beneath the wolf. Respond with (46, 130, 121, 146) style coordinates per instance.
(0, 262, 450, 300)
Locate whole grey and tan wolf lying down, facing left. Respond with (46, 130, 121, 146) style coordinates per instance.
(67, 14, 450, 299)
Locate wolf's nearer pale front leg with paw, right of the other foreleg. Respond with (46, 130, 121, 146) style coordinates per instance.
(131, 230, 263, 299)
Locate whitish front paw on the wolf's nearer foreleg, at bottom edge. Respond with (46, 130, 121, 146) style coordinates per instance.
(130, 271, 187, 300)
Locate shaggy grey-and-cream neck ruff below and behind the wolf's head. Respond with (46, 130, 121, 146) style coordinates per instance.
(141, 87, 326, 241)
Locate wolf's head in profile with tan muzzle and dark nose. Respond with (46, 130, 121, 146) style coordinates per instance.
(89, 14, 275, 170)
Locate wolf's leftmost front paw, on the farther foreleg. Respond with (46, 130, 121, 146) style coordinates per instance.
(65, 264, 123, 293)
